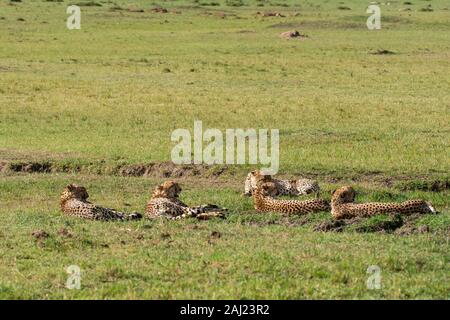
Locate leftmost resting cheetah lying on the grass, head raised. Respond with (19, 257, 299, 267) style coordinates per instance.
(60, 184, 142, 221)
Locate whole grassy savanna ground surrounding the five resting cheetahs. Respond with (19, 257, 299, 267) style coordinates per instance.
(0, 0, 450, 299)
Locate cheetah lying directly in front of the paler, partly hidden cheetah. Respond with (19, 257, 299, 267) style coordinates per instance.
(253, 177, 330, 214)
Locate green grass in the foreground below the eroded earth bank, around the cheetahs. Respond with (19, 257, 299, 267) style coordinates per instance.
(0, 174, 450, 299)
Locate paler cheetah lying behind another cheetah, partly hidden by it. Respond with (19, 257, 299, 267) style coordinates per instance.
(244, 170, 320, 197)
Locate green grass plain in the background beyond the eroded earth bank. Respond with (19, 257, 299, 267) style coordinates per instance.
(0, 1, 450, 174)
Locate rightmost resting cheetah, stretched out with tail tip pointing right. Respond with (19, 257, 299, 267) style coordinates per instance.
(331, 186, 436, 219)
